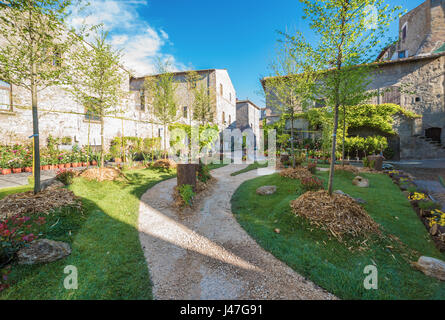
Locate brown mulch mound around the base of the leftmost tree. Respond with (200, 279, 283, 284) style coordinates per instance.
(0, 188, 82, 220)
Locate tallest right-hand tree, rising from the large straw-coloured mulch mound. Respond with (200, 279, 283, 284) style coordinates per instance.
(287, 0, 400, 194)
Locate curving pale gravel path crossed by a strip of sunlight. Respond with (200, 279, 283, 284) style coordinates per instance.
(139, 165, 335, 300)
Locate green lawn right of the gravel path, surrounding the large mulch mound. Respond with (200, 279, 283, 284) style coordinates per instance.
(232, 172, 445, 299)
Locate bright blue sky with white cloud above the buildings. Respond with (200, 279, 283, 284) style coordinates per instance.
(73, 0, 424, 107)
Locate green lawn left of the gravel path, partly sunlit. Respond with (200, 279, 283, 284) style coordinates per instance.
(0, 169, 174, 299)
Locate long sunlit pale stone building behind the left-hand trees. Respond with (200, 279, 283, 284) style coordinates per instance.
(0, 65, 236, 148)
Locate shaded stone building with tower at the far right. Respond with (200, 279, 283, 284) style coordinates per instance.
(262, 0, 445, 160)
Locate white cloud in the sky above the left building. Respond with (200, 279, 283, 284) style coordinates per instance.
(70, 0, 182, 76)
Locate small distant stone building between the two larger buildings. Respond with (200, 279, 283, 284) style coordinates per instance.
(236, 100, 261, 145)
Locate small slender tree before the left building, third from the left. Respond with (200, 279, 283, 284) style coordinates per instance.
(145, 61, 178, 157)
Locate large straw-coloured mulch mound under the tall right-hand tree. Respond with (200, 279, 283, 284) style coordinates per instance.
(290, 190, 381, 242)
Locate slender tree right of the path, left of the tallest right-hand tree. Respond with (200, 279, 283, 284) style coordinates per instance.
(265, 36, 315, 168)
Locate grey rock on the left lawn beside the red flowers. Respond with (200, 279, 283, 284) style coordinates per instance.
(17, 239, 71, 264)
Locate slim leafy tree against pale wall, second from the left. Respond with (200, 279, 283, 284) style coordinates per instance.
(68, 32, 128, 167)
